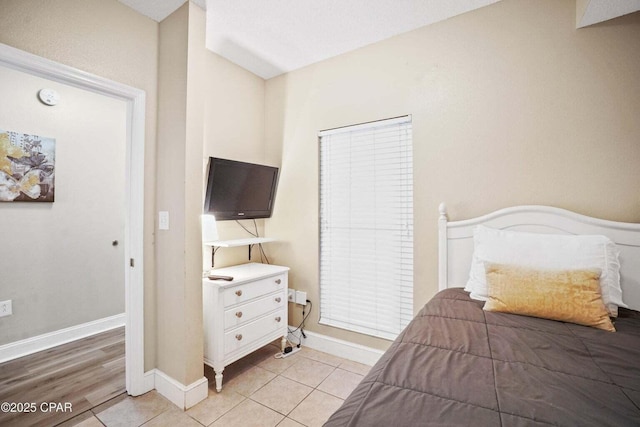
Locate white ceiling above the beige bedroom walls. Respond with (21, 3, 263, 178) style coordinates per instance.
(119, 0, 640, 79)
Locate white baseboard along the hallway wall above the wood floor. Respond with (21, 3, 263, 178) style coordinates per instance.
(0, 313, 126, 363)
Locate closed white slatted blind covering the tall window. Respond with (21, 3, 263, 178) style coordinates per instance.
(319, 116, 413, 339)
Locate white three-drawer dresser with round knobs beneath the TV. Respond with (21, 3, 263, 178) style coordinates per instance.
(202, 263, 289, 391)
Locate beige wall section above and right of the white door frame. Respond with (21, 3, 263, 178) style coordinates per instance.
(0, 0, 158, 369)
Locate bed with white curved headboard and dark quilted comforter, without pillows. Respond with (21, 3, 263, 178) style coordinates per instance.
(325, 205, 640, 427)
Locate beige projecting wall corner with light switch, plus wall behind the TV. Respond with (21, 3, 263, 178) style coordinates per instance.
(156, 3, 264, 385)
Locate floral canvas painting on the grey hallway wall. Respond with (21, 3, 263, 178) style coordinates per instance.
(0, 129, 56, 202)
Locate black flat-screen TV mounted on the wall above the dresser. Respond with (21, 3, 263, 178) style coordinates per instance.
(204, 157, 278, 220)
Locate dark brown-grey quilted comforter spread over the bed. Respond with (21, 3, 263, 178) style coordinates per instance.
(325, 289, 640, 427)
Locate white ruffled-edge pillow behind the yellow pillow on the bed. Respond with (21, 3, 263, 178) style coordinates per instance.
(464, 225, 627, 317)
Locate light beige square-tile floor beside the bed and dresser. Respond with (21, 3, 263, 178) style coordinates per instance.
(63, 344, 370, 427)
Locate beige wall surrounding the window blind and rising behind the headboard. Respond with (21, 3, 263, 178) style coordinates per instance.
(265, 0, 640, 348)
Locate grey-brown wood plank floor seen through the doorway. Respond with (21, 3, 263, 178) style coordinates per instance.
(0, 327, 125, 427)
